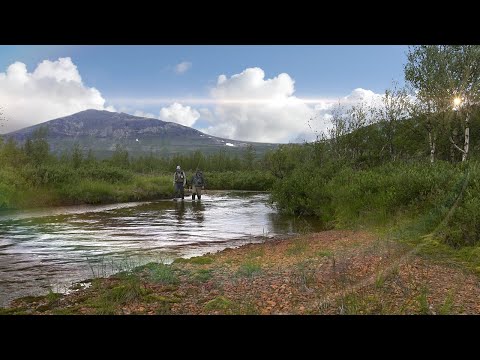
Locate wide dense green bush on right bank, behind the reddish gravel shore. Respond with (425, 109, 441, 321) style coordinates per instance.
(272, 162, 463, 225)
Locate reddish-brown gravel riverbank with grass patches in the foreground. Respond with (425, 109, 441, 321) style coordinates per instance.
(0, 230, 480, 314)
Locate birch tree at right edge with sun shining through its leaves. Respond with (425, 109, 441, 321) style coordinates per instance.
(405, 45, 480, 162)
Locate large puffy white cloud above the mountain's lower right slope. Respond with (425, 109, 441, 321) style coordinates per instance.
(202, 67, 314, 142)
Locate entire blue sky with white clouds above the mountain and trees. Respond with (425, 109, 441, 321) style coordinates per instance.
(0, 45, 408, 143)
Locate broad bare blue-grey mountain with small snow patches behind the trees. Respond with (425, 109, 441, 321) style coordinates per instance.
(5, 110, 277, 157)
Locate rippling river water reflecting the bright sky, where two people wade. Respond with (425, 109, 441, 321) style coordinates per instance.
(0, 192, 320, 306)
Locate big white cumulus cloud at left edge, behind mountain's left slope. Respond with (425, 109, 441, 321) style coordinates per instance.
(0, 57, 115, 132)
